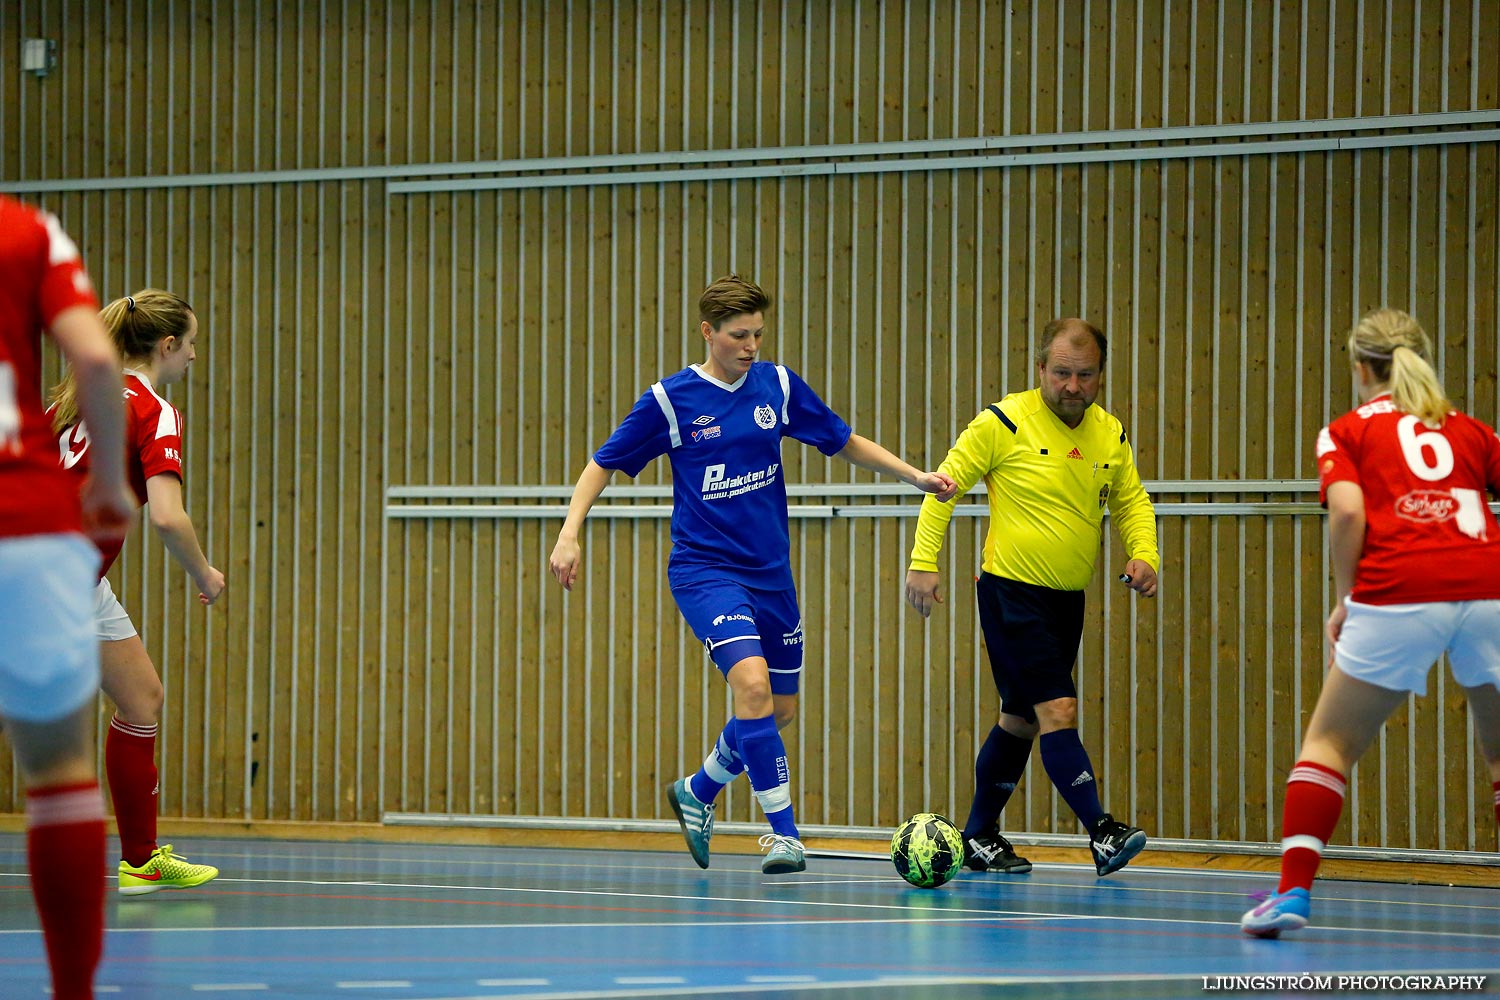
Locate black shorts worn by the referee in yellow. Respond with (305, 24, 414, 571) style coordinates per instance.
(975, 573, 1083, 723)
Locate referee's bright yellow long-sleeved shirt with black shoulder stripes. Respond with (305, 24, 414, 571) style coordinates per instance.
(909, 388, 1161, 591)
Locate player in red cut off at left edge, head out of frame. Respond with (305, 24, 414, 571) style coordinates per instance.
(0, 195, 135, 1000)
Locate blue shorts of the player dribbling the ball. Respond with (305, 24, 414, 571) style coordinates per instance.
(672, 580, 803, 694)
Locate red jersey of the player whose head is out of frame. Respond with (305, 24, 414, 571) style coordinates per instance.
(0, 195, 99, 538)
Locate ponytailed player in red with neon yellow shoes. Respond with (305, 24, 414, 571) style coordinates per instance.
(51, 288, 224, 895)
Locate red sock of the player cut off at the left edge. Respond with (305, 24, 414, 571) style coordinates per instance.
(26, 781, 104, 1000)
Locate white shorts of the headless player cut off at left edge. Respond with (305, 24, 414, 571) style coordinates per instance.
(0, 534, 99, 723)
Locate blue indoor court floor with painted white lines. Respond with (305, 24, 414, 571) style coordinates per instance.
(0, 834, 1500, 1000)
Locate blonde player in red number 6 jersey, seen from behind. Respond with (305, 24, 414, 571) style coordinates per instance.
(1241, 309, 1500, 937)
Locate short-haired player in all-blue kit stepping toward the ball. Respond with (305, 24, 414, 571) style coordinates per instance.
(551, 274, 956, 874)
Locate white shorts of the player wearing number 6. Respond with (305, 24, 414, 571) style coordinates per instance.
(1334, 601, 1500, 694)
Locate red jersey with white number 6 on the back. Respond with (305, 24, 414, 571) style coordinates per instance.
(1317, 396, 1500, 604)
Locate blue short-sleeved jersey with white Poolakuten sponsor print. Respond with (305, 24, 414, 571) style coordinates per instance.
(594, 361, 852, 591)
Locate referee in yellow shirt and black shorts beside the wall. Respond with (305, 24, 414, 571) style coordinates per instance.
(906, 319, 1161, 876)
